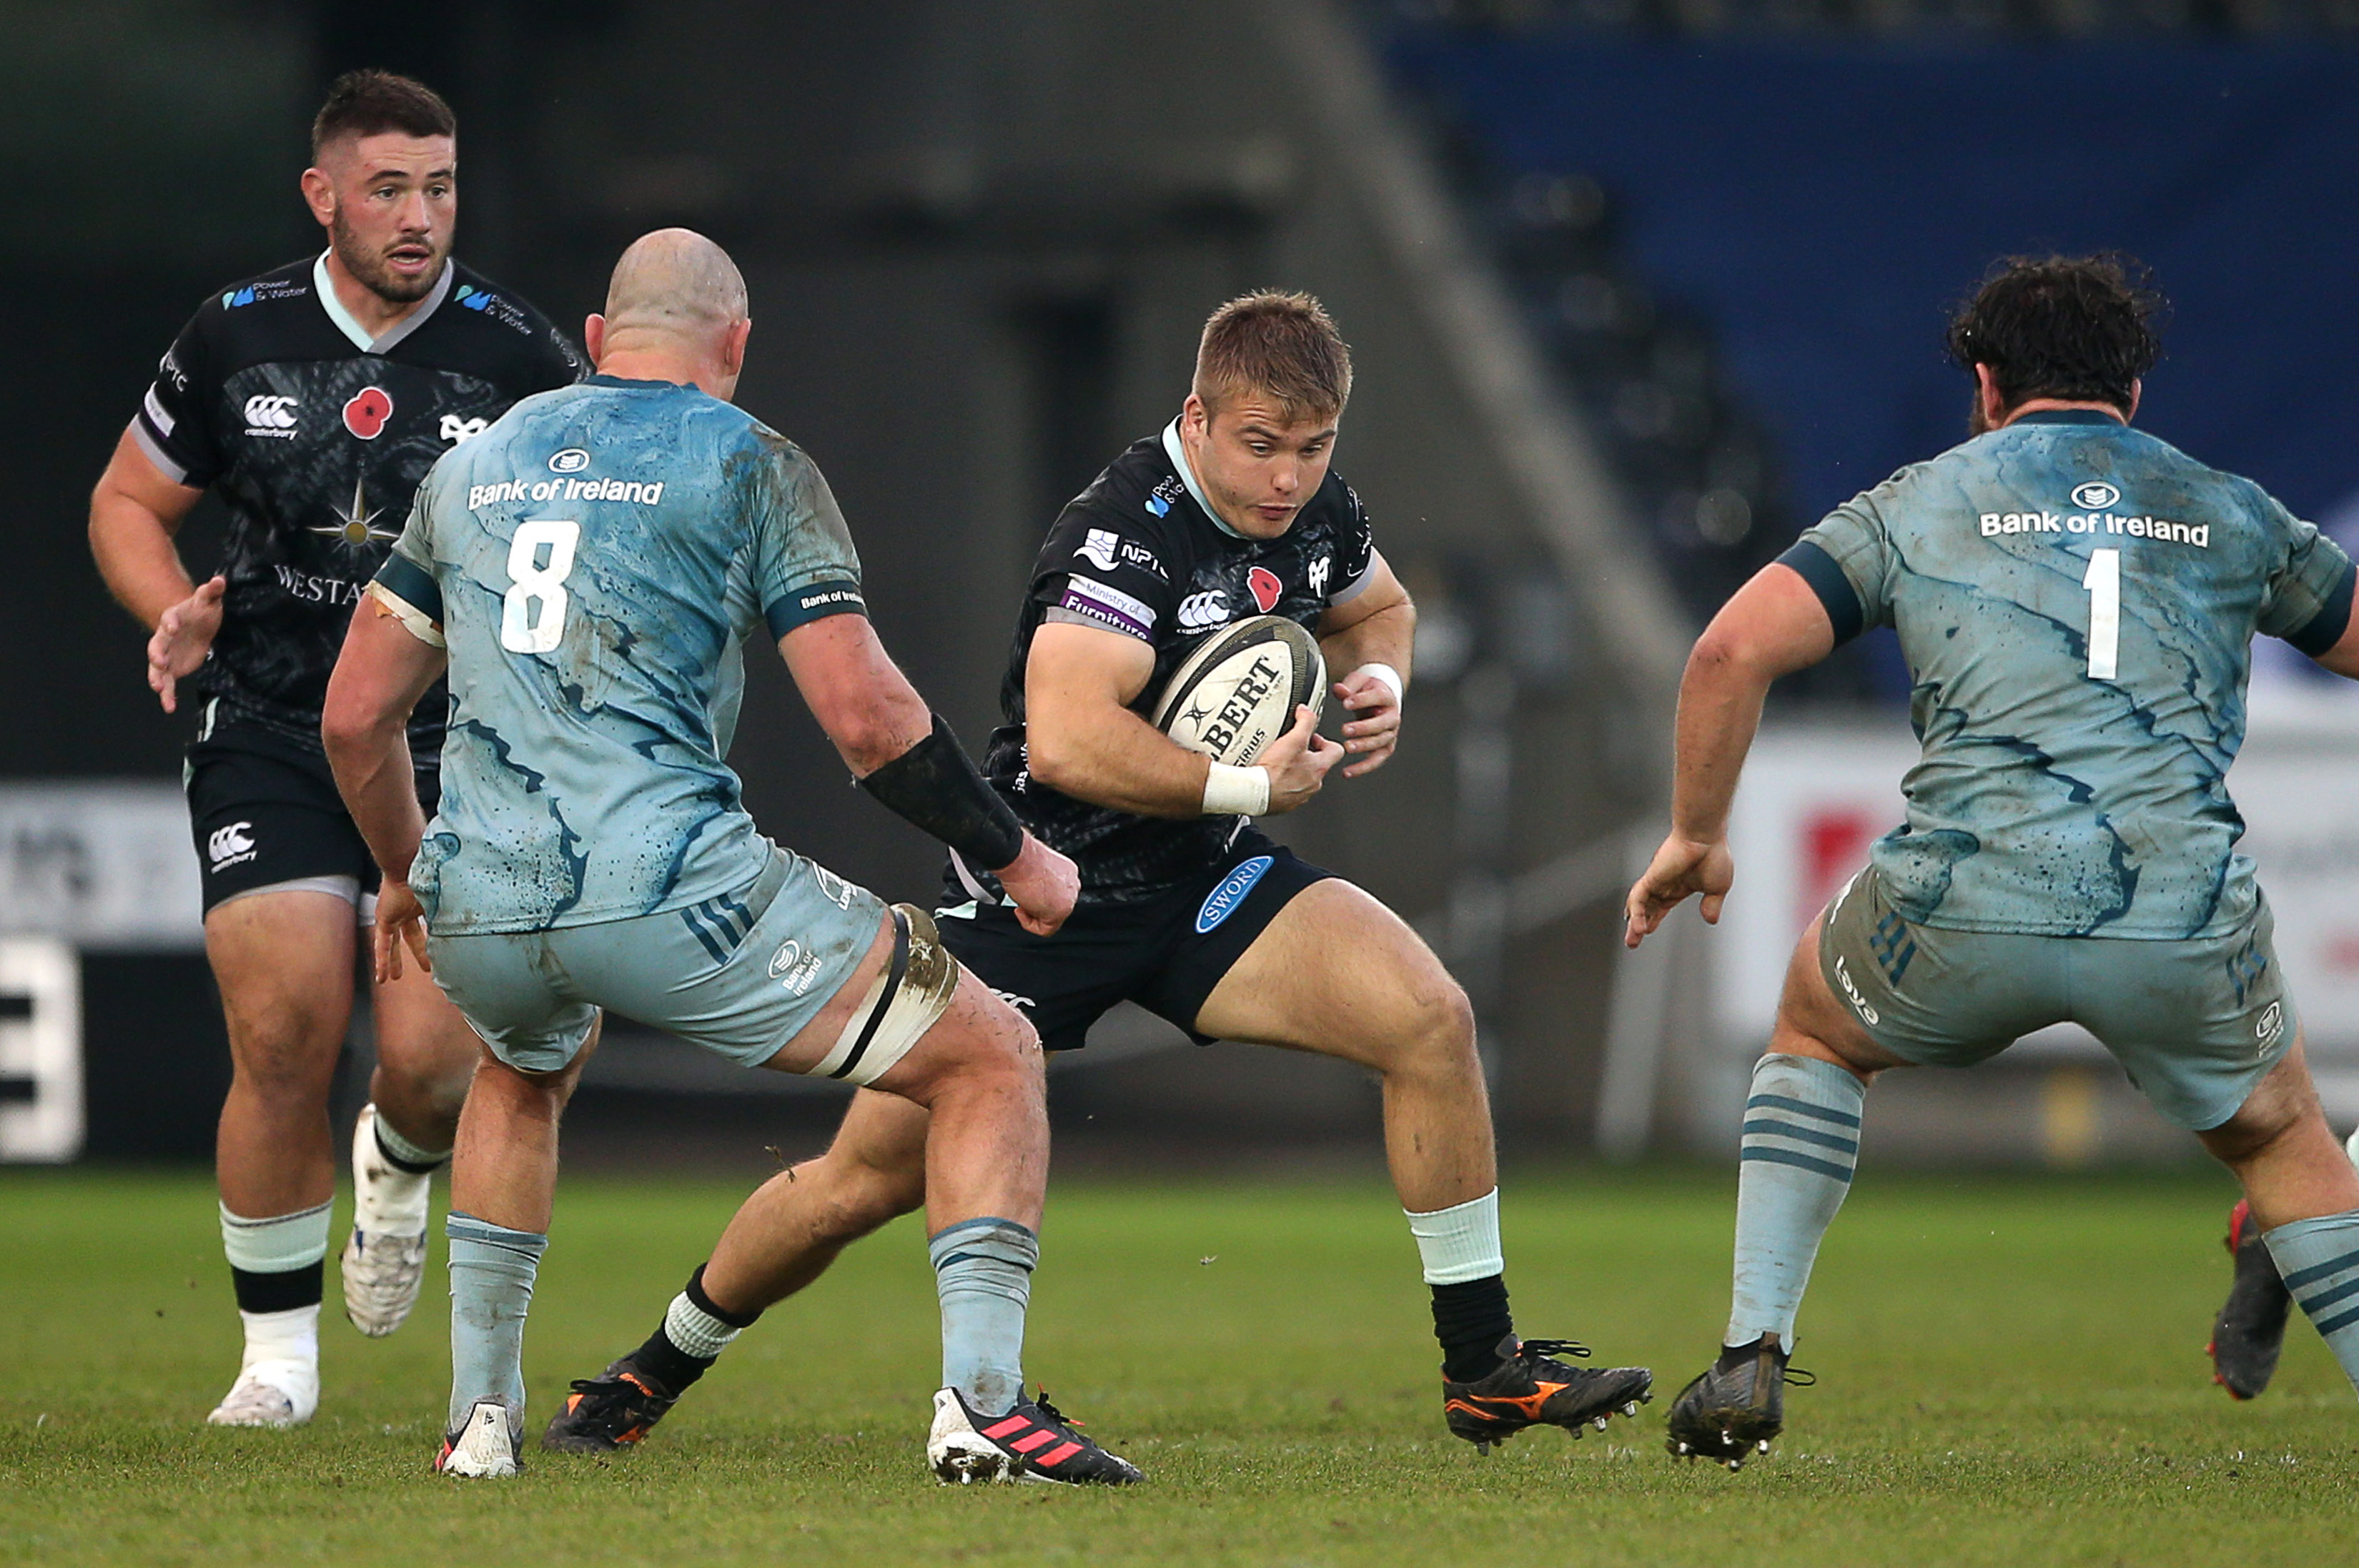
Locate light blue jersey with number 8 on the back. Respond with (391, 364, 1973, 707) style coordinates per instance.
(377, 375, 866, 936)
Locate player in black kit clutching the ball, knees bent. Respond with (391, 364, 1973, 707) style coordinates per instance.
(545, 292, 1649, 1455)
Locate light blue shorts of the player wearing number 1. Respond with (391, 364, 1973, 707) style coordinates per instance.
(1819, 865, 2295, 1132)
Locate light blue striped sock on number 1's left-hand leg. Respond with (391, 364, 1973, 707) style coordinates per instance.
(1722, 1056, 1869, 1346)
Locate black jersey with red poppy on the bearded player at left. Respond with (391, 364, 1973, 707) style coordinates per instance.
(132, 257, 583, 769)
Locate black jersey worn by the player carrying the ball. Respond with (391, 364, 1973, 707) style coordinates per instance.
(946, 422, 1375, 905)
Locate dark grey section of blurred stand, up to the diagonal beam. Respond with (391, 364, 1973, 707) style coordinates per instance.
(0, 0, 1687, 1158)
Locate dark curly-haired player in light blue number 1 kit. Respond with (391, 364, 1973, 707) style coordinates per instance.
(1628, 257, 2359, 1469)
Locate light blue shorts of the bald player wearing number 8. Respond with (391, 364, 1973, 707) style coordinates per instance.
(427, 844, 885, 1073)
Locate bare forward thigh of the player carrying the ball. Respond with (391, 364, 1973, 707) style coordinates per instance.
(1196, 877, 1475, 1068)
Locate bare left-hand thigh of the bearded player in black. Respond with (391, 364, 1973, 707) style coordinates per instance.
(205, 889, 356, 1082)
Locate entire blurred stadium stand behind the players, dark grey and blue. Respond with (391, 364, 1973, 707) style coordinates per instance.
(0, 0, 2359, 1163)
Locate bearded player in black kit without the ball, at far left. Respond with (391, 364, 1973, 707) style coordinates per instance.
(89, 71, 580, 1426)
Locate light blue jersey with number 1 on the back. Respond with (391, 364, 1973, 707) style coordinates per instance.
(1784, 410, 2352, 938)
